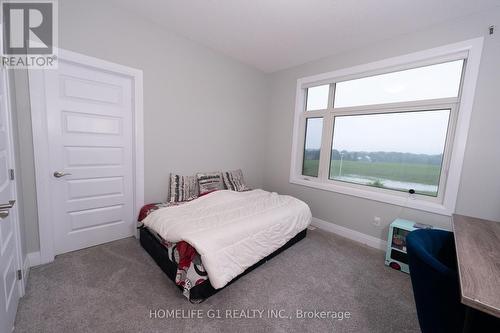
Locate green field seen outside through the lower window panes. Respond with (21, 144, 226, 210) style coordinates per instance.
(303, 160, 441, 195)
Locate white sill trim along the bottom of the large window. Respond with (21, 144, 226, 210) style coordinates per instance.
(290, 176, 452, 216)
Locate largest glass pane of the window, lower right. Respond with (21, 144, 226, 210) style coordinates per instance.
(330, 109, 450, 197)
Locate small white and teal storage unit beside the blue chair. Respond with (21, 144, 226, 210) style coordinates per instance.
(385, 219, 432, 274)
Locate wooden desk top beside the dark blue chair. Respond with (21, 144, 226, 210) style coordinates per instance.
(453, 215, 500, 318)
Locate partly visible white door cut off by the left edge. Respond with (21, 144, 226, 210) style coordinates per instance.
(0, 69, 20, 333)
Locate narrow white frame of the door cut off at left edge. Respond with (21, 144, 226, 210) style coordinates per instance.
(0, 67, 28, 297)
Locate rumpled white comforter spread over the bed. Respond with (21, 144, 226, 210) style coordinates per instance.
(143, 190, 311, 289)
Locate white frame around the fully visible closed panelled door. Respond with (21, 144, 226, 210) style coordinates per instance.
(28, 49, 144, 264)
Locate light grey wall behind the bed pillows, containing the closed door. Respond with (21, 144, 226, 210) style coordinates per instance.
(13, 0, 268, 252)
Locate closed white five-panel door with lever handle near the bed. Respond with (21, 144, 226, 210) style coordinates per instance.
(39, 58, 135, 254)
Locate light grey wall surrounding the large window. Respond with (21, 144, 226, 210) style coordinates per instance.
(264, 10, 500, 239)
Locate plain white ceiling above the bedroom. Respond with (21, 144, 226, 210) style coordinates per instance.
(111, 0, 500, 72)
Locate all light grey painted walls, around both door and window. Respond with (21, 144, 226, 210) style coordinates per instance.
(11, 0, 500, 252)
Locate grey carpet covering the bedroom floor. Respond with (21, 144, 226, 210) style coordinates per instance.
(16, 230, 419, 332)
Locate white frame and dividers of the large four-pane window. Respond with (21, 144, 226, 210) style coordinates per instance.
(290, 37, 483, 216)
